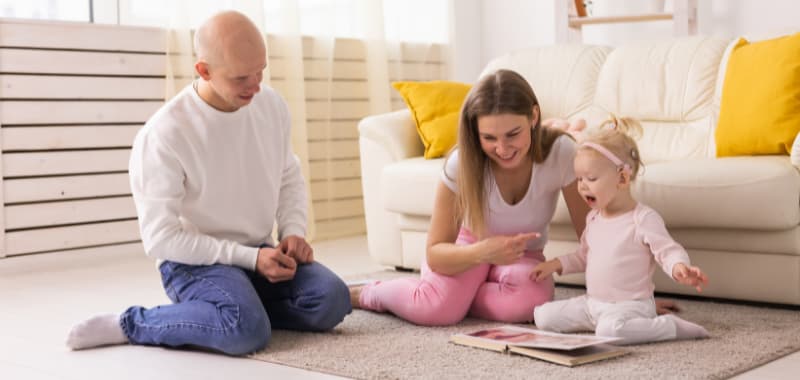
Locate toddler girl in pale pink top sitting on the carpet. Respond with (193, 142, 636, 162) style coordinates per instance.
(531, 116, 708, 344)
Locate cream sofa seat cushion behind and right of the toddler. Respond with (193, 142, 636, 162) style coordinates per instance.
(554, 156, 800, 231)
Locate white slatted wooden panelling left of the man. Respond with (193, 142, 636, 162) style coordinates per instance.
(0, 20, 166, 257)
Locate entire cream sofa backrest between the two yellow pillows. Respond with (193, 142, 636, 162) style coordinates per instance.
(481, 36, 729, 163)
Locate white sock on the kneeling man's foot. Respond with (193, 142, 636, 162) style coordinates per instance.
(67, 314, 128, 350)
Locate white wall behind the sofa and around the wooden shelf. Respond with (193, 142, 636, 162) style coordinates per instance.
(454, 0, 800, 82)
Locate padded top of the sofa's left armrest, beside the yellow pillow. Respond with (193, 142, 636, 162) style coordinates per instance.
(358, 109, 425, 161)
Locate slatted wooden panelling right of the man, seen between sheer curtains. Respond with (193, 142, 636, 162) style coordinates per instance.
(268, 38, 447, 239)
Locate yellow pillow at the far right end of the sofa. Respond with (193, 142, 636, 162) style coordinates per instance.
(715, 33, 800, 157)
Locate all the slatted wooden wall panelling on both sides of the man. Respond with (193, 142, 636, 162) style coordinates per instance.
(0, 19, 446, 257)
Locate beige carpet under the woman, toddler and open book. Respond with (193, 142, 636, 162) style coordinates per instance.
(251, 274, 800, 380)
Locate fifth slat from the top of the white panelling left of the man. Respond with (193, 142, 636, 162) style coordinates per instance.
(1, 125, 142, 152)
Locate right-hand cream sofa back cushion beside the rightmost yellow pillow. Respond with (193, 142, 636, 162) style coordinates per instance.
(582, 37, 728, 163)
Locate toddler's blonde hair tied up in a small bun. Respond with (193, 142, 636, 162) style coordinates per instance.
(579, 114, 644, 180)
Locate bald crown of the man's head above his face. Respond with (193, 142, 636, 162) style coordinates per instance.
(194, 11, 266, 66)
